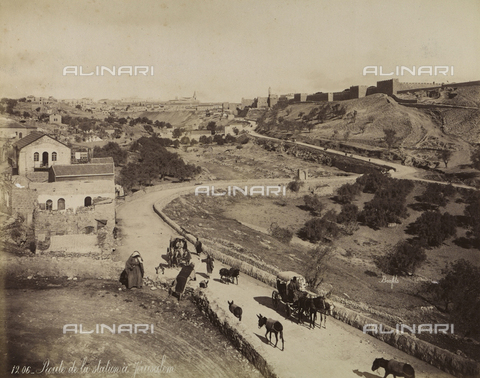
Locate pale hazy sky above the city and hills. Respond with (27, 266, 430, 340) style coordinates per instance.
(0, 0, 480, 102)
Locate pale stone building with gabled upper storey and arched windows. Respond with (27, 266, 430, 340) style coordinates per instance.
(0, 133, 115, 252)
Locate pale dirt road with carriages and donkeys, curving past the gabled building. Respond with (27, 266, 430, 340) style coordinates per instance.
(117, 180, 450, 378)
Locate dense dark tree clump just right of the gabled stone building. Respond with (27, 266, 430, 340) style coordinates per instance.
(120, 136, 201, 191)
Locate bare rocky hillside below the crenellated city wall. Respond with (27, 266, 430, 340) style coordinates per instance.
(255, 86, 480, 169)
